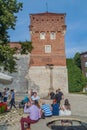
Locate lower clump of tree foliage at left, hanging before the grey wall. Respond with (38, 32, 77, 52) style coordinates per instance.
(0, 45, 17, 73)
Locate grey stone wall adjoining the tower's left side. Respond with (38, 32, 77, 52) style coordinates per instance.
(0, 54, 29, 93)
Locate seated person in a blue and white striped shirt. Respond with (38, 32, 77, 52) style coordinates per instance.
(41, 102, 52, 118)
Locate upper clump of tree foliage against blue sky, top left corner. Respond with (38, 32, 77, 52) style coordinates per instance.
(0, 0, 22, 45)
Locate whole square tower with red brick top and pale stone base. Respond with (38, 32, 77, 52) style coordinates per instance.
(28, 12, 68, 94)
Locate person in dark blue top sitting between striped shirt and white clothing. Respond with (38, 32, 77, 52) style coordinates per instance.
(51, 99, 59, 116)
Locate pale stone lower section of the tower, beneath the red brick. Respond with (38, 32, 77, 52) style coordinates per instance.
(28, 66, 68, 96)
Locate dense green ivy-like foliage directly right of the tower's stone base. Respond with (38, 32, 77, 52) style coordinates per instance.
(67, 59, 86, 92)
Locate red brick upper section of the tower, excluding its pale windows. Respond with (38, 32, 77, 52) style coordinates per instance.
(30, 13, 66, 66)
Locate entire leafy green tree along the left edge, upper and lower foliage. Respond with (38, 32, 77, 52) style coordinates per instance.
(0, 0, 22, 72)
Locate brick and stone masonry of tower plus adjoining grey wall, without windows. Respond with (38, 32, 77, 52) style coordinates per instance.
(0, 12, 68, 96)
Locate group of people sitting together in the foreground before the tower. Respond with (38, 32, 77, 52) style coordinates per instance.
(20, 89, 71, 130)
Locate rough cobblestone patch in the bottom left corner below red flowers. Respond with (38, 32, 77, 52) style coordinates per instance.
(0, 108, 24, 130)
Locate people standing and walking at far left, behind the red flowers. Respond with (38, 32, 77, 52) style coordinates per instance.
(0, 88, 17, 110)
